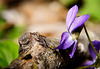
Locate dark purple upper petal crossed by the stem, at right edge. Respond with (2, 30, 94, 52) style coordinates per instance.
(88, 40, 100, 61)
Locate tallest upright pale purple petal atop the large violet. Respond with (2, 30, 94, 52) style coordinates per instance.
(66, 5, 78, 30)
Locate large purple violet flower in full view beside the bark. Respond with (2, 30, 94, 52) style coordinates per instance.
(55, 5, 90, 58)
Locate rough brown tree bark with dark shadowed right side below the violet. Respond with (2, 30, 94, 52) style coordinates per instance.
(5, 32, 89, 69)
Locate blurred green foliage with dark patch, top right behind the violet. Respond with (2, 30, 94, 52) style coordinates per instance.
(59, 0, 100, 23)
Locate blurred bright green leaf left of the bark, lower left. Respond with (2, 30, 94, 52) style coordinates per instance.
(0, 40, 18, 68)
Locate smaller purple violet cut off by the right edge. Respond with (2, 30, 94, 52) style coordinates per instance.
(82, 40, 100, 69)
